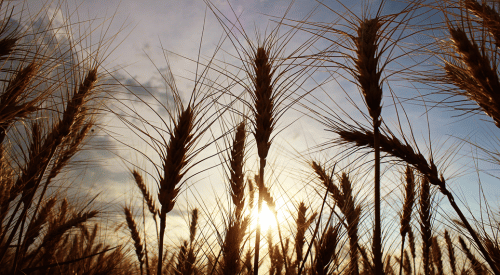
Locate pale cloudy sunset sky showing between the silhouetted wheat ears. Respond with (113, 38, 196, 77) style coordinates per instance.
(10, 0, 499, 268)
